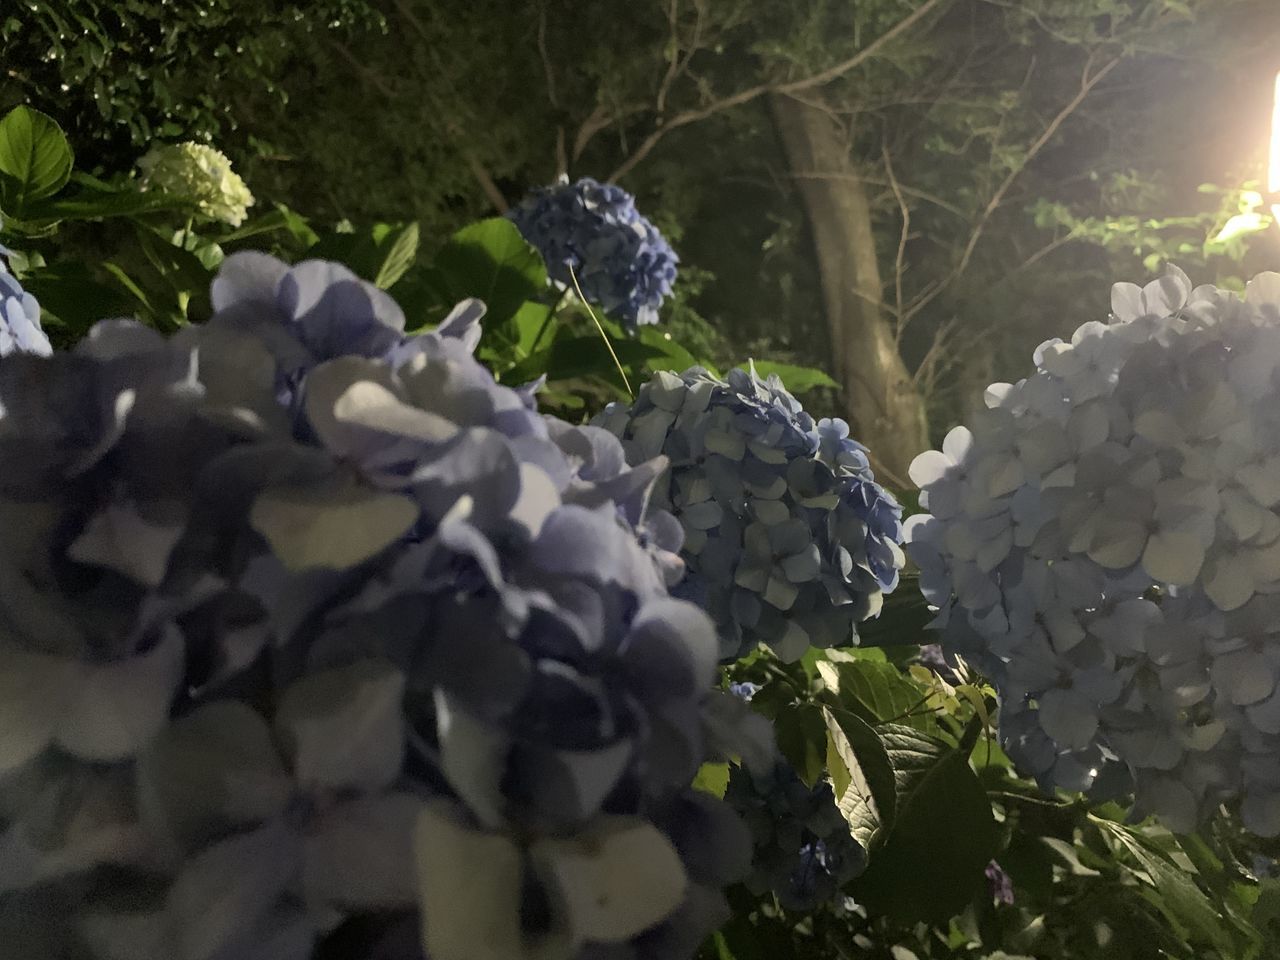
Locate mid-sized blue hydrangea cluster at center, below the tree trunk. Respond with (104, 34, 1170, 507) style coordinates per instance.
(596, 367, 904, 660)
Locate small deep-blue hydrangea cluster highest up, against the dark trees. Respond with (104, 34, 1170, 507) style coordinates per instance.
(507, 177, 680, 328)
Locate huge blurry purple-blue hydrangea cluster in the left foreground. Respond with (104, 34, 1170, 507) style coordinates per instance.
(0, 252, 772, 960)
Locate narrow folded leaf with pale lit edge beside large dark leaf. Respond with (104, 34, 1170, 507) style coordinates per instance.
(822, 708, 897, 849)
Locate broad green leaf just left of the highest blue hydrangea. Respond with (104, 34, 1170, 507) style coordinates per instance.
(433, 216, 547, 324)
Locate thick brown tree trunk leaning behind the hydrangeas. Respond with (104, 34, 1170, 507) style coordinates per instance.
(771, 96, 929, 488)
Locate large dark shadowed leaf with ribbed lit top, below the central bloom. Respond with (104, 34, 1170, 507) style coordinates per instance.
(851, 726, 997, 923)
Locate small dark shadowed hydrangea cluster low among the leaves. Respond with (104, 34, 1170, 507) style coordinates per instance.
(724, 760, 867, 913)
